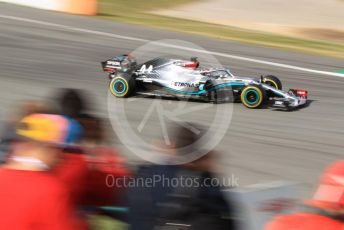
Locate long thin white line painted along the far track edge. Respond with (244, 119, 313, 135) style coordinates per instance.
(0, 14, 344, 78)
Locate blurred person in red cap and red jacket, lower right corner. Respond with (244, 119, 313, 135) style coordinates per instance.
(265, 161, 344, 230)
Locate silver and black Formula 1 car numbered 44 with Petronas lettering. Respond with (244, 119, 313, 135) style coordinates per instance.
(102, 55, 308, 109)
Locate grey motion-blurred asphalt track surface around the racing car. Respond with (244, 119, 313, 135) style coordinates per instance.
(0, 3, 344, 194)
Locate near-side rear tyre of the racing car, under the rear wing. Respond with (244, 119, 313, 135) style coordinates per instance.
(109, 74, 135, 97)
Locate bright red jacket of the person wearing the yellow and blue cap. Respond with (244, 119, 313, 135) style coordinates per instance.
(0, 168, 83, 230)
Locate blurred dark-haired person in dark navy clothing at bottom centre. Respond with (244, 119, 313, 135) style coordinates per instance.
(129, 124, 235, 230)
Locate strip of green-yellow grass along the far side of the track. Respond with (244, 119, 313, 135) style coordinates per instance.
(99, 0, 344, 58)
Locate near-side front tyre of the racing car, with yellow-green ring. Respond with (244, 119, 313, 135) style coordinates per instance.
(240, 85, 267, 109)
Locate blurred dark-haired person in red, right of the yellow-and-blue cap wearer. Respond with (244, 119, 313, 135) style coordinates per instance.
(79, 115, 131, 206)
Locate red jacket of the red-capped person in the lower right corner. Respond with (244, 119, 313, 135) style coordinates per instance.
(265, 213, 344, 230)
